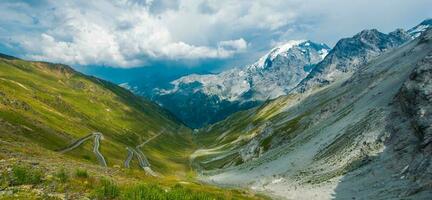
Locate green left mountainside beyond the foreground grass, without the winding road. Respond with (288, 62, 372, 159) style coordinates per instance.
(0, 55, 192, 173)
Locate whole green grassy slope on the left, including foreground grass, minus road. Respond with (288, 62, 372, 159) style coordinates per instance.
(0, 54, 261, 199)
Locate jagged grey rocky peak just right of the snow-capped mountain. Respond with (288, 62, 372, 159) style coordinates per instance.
(295, 29, 411, 92)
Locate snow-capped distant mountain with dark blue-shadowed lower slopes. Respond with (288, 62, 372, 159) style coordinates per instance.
(153, 41, 329, 128)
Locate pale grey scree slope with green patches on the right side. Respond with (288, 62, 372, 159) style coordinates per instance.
(191, 29, 432, 199)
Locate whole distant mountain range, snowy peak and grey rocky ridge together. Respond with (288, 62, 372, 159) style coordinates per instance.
(123, 19, 432, 128)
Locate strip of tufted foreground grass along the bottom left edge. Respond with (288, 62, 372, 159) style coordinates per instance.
(0, 160, 265, 200)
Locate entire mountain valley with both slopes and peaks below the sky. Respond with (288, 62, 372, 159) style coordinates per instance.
(0, 14, 432, 200)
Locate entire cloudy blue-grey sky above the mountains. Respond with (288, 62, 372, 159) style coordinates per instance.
(0, 0, 432, 68)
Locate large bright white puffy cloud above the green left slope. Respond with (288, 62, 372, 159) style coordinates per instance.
(0, 2, 247, 67)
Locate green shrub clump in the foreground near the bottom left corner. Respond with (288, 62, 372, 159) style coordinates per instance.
(10, 165, 42, 185)
